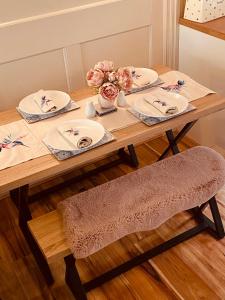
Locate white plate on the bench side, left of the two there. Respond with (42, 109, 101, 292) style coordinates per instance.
(44, 119, 105, 151)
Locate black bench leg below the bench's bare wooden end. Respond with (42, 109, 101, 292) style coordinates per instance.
(64, 254, 87, 300)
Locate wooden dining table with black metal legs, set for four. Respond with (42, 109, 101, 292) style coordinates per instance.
(0, 66, 225, 283)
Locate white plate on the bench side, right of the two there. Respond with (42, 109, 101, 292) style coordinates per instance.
(133, 91, 188, 118)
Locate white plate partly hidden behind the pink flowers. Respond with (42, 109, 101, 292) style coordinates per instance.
(132, 68, 159, 89)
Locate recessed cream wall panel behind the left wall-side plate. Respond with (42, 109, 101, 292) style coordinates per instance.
(0, 50, 67, 110)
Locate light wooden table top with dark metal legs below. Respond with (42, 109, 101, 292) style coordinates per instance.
(0, 66, 225, 194)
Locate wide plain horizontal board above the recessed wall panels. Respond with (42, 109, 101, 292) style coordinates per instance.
(0, 0, 151, 63)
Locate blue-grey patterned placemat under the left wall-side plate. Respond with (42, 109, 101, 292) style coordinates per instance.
(16, 100, 80, 123)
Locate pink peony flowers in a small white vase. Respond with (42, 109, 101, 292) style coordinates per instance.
(86, 60, 133, 108)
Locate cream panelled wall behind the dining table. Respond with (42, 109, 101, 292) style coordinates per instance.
(0, 0, 165, 110)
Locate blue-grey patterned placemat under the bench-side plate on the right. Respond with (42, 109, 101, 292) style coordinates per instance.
(128, 103, 196, 126)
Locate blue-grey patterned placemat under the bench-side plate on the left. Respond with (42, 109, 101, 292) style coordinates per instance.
(43, 130, 115, 160)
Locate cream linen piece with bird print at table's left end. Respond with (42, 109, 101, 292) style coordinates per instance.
(0, 120, 49, 170)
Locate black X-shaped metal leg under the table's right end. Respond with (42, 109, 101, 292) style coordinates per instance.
(158, 120, 197, 160)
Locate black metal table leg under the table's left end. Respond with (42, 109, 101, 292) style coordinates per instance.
(13, 185, 54, 285)
